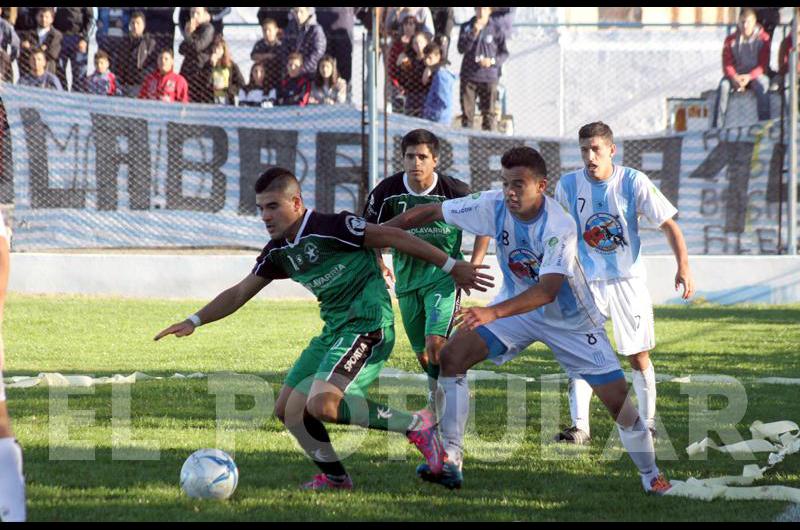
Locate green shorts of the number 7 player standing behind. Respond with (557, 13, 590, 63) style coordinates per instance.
(397, 276, 461, 353)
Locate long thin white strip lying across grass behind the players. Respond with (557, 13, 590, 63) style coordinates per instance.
(5, 368, 800, 388)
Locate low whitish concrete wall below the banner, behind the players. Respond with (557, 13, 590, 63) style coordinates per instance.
(9, 252, 800, 304)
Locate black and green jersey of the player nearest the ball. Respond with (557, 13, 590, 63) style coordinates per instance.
(253, 210, 394, 331)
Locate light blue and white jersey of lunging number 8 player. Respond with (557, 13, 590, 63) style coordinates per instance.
(442, 191, 605, 331)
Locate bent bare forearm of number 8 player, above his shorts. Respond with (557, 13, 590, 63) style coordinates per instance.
(456, 274, 564, 331)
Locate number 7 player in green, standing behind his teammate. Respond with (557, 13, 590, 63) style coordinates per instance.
(364, 129, 491, 408)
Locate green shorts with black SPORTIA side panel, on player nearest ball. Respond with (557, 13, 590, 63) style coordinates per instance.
(284, 325, 394, 398)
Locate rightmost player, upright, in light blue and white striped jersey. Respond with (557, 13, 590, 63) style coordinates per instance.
(555, 122, 694, 444)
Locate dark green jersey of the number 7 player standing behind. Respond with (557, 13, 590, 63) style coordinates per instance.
(364, 173, 470, 296)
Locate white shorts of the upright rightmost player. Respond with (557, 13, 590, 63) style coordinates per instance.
(589, 278, 656, 355)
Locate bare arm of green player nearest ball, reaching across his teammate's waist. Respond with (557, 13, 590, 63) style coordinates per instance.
(364, 221, 494, 294)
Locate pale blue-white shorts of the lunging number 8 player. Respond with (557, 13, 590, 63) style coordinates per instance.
(476, 313, 622, 383)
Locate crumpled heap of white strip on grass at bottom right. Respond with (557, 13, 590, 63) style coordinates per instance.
(667, 421, 800, 504)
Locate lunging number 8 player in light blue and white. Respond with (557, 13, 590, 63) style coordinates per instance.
(386, 147, 670, 493)
